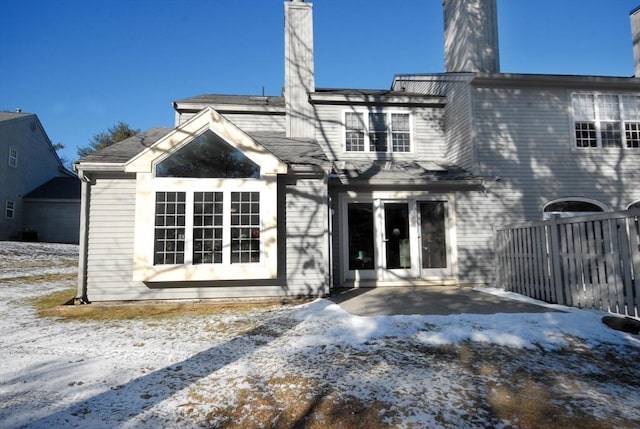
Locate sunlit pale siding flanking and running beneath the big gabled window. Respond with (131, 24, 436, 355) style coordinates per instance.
(87, 178, 329, 301)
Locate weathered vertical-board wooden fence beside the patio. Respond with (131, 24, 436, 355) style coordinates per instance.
(496, 209, 640, 317)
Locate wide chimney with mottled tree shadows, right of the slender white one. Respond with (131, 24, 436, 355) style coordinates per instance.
(443, 0, 500, 73)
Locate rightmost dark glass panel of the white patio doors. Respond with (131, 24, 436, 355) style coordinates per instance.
(418, 201, 447, 269)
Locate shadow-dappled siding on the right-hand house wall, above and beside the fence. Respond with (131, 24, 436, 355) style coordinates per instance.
(456, 87, 640, 283)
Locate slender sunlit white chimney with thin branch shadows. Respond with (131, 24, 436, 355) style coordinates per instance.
(284, 0, 315, 138)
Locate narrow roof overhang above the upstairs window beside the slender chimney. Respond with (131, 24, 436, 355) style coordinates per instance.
(309, 92, 446, 107)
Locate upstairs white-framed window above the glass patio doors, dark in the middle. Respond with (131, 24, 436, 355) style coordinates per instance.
(344, 111, 411, 153)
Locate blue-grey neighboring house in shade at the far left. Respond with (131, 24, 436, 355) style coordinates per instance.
(0, 112, 80, 243)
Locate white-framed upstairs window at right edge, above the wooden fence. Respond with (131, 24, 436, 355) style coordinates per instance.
(572, 93, 640, 148)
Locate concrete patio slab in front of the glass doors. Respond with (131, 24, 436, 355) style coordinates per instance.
(330, 286, 555, 316)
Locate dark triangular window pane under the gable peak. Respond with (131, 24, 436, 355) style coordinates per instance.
(156, 130, 260, 179)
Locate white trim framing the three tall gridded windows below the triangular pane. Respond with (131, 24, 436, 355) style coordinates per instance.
(133, 173, 277, 282)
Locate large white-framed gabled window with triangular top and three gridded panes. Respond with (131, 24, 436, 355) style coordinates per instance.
(133, 115, 286, 282)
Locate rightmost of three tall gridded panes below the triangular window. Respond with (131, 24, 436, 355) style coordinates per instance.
(231, 192, 260, 264)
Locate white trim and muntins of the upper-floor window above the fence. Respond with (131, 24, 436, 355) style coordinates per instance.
(569, 91, 640, 151)
